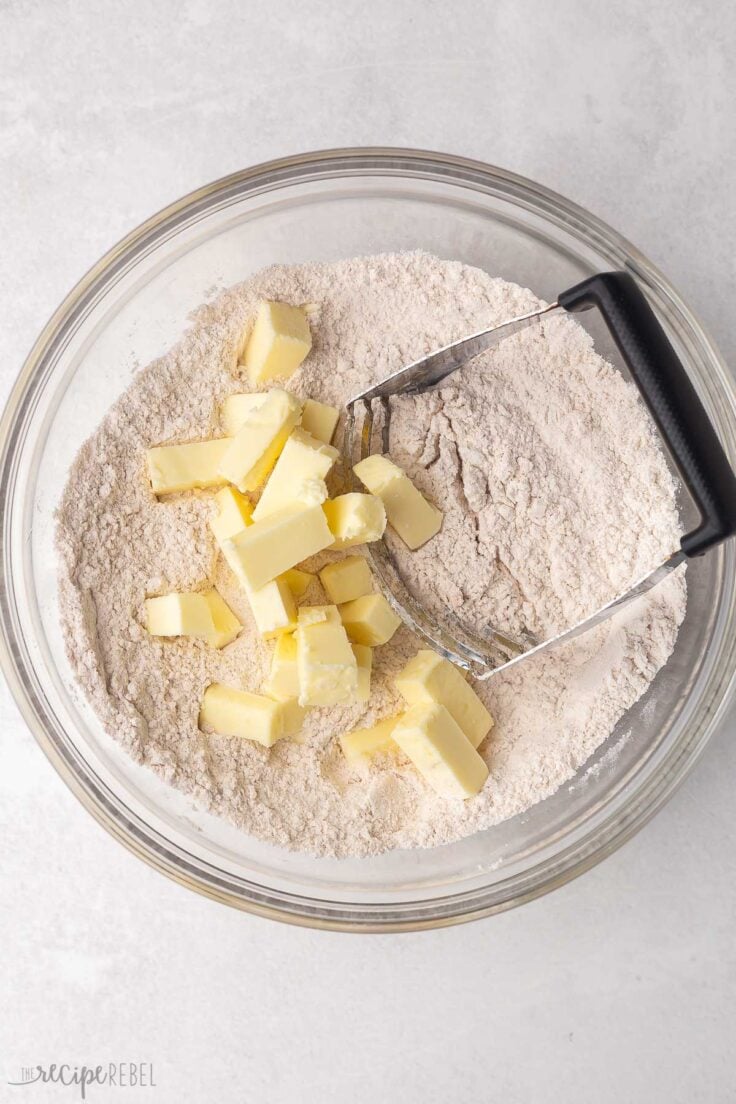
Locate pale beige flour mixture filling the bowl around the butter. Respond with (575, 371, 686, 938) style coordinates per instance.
(57, 253, 685, 856)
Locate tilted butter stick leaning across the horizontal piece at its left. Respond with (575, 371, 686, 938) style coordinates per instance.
(220, 389, 301, 490)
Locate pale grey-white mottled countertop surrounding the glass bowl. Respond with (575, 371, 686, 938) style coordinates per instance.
(0, 0, 736, 1104)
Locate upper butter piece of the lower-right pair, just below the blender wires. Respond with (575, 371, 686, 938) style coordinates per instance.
(396, 649, 493, 747)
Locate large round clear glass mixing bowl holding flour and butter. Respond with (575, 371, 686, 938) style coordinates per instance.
(0, 149, 736, 932)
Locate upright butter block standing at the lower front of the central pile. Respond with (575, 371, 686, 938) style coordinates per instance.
(296, 606, 358, 705)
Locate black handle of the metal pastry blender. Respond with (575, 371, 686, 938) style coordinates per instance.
(557, 272, 736, 556)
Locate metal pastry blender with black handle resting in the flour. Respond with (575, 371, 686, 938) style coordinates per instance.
(344, 272, 736, 679)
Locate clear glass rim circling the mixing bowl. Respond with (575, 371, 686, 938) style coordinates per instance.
(0, 147, 736, 933)
